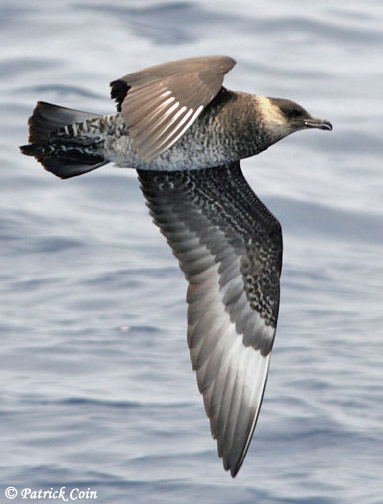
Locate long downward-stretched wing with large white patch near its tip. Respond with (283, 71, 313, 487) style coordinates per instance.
(138, 163, 282, 476)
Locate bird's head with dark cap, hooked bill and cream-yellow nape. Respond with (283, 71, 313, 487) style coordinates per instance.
(257, 96, 332, 142)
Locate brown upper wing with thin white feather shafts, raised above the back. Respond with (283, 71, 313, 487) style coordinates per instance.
(111, 56, 235, 161)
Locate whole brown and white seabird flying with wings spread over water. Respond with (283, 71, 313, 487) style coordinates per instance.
(21, 56, 332, 477)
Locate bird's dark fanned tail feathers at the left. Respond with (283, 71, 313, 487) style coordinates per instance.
(20, 102, 108, 179)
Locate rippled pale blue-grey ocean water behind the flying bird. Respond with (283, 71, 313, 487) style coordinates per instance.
(0, 0, 383, 504)
